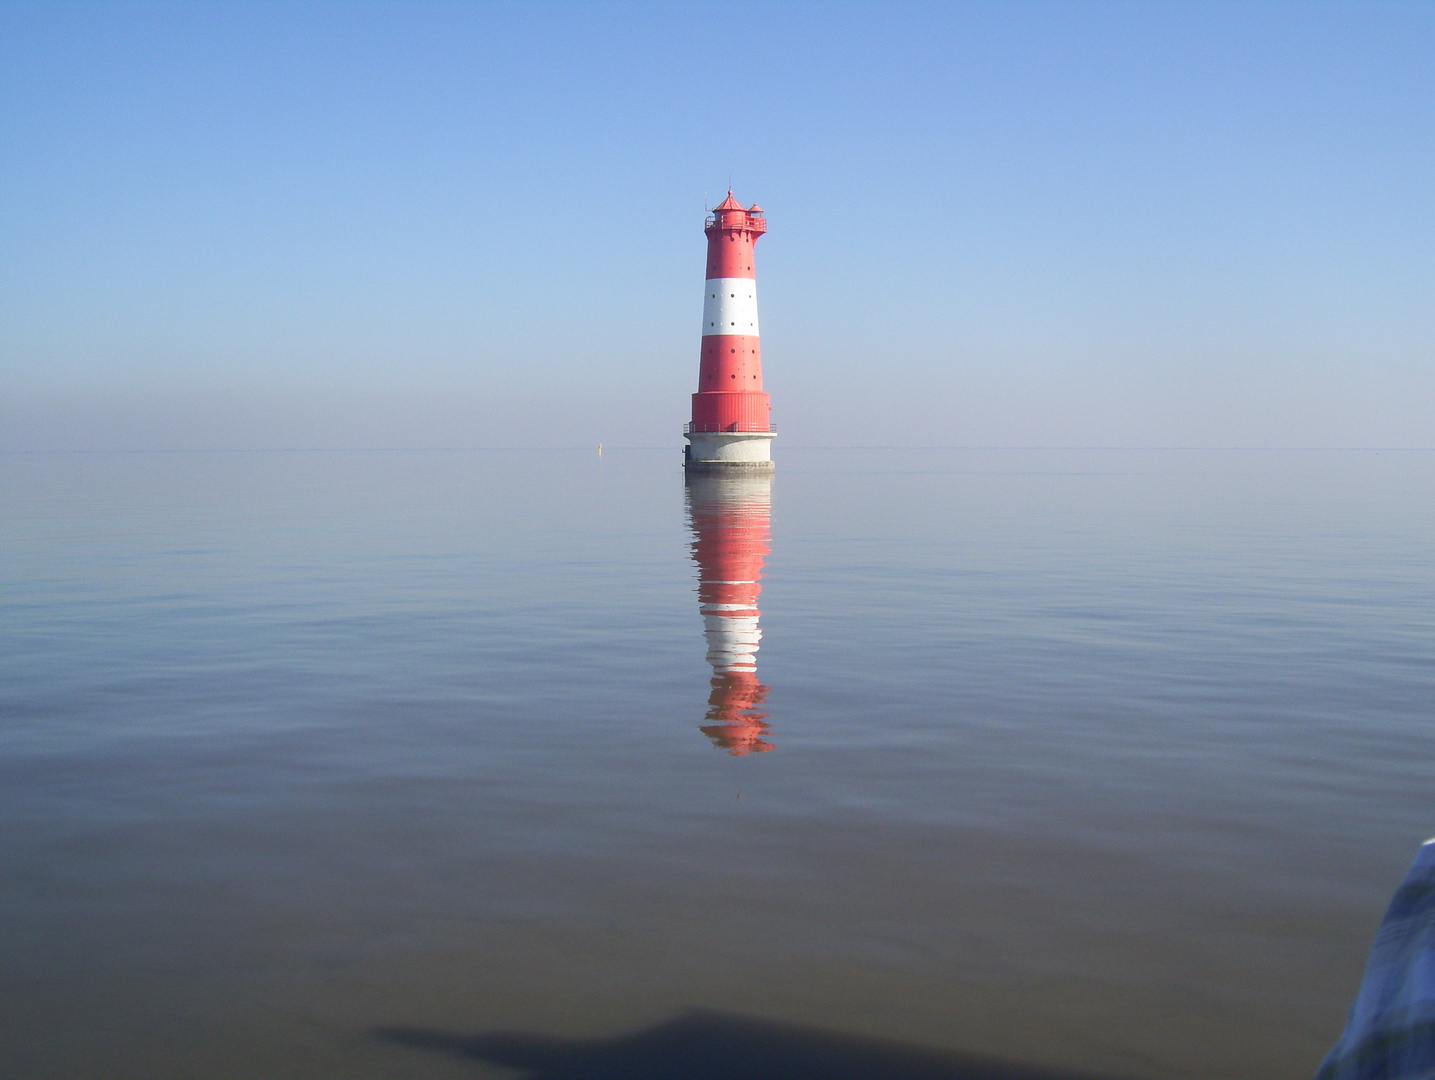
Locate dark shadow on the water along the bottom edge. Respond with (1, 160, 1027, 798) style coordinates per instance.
(375, 1011, 1136, 1080)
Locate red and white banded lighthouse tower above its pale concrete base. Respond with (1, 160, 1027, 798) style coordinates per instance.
(689, 191, 771, 432)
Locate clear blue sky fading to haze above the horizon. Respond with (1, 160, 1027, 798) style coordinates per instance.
(0, 0, 1435, 455)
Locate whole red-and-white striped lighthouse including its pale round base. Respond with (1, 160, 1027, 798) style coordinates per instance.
(683, 191, 776, 473)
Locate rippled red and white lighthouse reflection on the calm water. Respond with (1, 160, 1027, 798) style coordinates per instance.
(687, 472, 772, 756)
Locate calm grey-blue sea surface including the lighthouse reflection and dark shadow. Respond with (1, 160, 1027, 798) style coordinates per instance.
(0, 446, 1435, 1080)
